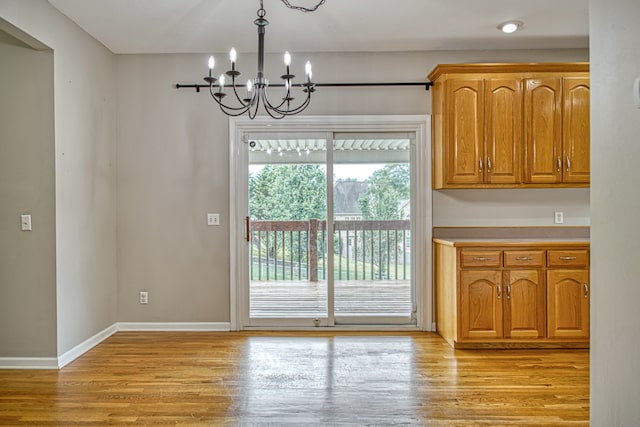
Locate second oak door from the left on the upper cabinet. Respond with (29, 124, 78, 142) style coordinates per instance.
(485, 79, 522, 184)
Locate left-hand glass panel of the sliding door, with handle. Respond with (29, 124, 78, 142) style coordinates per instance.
(248, 134, 329, 326)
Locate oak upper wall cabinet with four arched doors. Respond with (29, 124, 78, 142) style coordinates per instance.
(429, 63, 589, 189)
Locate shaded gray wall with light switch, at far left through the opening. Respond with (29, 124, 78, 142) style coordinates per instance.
(0, 31, 57, 357)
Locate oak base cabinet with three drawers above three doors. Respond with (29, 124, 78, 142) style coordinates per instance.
(434, 241, 590, 348)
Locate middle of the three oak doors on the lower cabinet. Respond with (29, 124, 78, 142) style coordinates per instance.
(503, 269, 546, 338)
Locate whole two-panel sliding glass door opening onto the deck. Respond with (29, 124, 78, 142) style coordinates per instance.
(232, 118, 424, 328)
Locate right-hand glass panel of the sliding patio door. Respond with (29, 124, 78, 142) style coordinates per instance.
(333, 133, 414, 324)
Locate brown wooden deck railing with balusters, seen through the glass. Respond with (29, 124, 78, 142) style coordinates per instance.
(250, 219, 411, 282)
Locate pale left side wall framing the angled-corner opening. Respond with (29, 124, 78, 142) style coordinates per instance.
(0, 0, 116, 356)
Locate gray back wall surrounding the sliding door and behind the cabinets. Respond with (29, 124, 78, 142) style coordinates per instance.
(117, 50, 589, 322)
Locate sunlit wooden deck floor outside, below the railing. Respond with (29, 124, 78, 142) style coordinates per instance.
(249, 280, 413, 318)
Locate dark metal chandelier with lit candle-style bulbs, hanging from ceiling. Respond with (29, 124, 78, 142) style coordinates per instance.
(204, 0, 325, 119)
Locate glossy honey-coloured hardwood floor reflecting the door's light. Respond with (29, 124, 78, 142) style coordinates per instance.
(0, 332, 589, 426)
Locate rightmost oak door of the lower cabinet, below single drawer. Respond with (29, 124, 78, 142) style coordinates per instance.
(547, 270, 589, 338)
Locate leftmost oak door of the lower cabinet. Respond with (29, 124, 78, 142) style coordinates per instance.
(459, 270, 503, 339)
